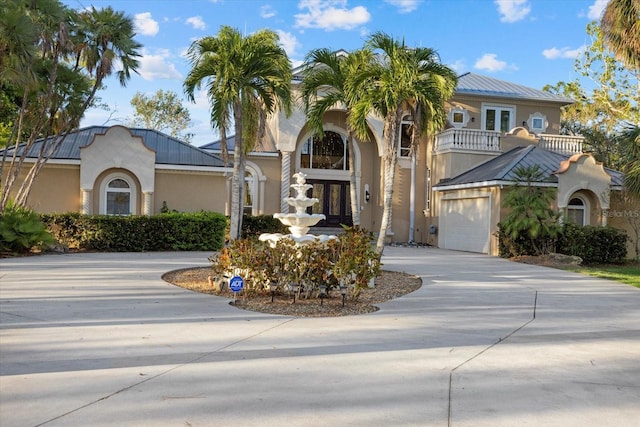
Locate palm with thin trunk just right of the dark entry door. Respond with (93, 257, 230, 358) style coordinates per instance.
(302, 48, 373, 227)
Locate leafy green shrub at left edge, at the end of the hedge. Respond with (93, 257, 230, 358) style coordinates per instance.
(0, 203, 54, 253)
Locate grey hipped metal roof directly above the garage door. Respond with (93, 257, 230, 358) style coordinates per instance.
(434, 145, 622, 191)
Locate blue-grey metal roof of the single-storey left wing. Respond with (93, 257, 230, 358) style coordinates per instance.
(1, 126, 225, 167)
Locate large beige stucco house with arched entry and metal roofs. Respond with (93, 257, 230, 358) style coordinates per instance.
(3, 73, 631, 255)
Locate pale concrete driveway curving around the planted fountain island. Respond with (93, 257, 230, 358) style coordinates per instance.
(0, 247, 640, 427)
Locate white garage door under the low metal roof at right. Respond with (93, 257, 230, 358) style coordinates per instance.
(439, 197, 491, 254)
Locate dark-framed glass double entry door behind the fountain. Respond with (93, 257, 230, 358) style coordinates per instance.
(307, 180, 353, 227)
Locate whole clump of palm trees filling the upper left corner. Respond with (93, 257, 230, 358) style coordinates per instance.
(0, 0, 142, 210)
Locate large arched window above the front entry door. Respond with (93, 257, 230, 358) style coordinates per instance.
(300, 131, 349, 171)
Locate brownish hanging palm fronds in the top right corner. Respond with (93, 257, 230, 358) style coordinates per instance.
(600, 0, 640, 70)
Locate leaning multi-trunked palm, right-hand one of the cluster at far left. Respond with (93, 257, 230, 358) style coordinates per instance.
(0, 0, 141, 209)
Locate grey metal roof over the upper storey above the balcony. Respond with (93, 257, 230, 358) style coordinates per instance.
(455, 73, 574, 105)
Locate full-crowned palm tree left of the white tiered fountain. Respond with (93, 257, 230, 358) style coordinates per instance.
(184, 26, 292, 240)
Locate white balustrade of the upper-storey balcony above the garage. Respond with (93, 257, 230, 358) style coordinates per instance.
(434, 128, 584, 156)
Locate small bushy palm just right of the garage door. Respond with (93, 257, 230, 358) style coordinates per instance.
(499, 165, 560, 255)
